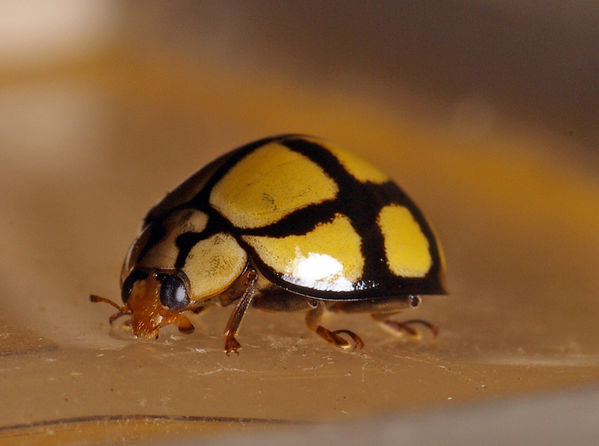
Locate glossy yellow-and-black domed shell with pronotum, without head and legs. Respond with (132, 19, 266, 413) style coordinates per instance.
(122, 135, 444, 303)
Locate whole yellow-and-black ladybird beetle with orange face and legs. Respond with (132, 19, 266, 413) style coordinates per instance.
(91, 135, 446, 354)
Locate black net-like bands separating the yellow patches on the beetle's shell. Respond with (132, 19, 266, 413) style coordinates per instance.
(129, 134, 445, 300)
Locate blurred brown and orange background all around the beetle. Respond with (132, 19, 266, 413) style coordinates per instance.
(0, 0, 599, 444)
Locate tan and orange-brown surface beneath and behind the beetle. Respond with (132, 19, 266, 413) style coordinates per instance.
(0, 30, 599, 444)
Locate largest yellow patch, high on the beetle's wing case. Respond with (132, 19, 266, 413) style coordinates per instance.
(210, 143, 338, 228)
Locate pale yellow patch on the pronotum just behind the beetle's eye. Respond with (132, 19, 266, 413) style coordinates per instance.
(183, 233, 247, 300)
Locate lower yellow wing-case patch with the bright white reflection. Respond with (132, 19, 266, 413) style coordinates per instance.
(243, 214, 364, 291)
